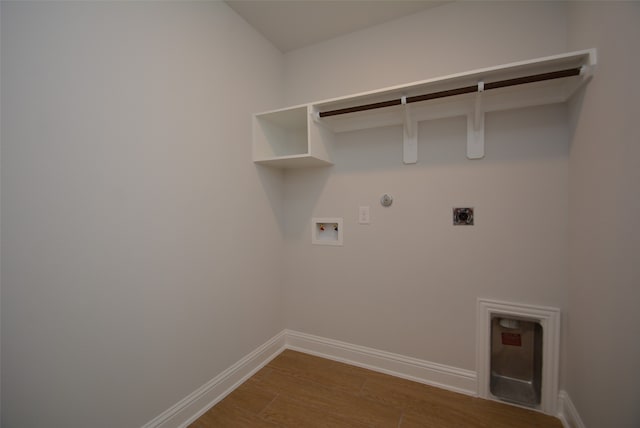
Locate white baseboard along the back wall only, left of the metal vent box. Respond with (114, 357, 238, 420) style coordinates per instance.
(285, 330, 476, 396)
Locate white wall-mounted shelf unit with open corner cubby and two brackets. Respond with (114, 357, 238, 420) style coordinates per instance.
(253, 49, 596, 168)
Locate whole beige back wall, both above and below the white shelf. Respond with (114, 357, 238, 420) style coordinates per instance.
(284, 2, 568, 370)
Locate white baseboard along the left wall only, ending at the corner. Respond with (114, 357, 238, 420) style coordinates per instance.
(142, 331, 285, 428)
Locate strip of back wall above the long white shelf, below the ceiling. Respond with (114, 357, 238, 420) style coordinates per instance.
(285, 1, 566, 105)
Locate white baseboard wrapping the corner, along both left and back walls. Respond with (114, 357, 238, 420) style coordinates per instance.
(142, 330, 477, 428)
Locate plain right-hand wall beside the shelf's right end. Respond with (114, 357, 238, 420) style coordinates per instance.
(566, 2, 640, 428)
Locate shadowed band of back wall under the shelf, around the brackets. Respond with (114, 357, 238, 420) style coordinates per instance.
(333, 105, 568, 174)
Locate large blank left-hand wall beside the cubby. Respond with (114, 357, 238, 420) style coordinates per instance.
(1, 2, 284, 427)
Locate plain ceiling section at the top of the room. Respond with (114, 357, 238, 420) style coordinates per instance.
(225, 0, 446, 52)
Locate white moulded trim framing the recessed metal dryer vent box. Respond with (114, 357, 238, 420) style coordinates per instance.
(476, 298, 560, 416)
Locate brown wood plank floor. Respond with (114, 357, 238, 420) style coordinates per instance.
(190, 350, 562, 428)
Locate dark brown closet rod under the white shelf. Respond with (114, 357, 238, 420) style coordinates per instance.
(318, 67, 581, 117)
